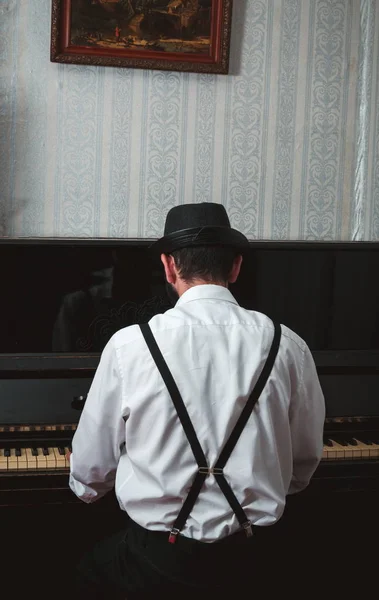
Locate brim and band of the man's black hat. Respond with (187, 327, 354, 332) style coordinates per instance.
(150, 227, 249, 255)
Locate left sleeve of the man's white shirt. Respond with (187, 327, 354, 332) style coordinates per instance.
(69, 338, 125, 503)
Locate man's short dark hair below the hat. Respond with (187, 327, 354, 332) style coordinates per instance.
(171, 246, 239, 283)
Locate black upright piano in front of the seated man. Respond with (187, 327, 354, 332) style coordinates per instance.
(0, 239, 379, 597)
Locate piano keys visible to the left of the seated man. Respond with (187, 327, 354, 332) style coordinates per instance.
(0, 446, 70, 472)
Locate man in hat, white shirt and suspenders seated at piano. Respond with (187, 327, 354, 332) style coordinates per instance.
(70, 203, 325, 598)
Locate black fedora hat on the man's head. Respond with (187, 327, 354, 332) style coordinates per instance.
(151, 202, 249, 254)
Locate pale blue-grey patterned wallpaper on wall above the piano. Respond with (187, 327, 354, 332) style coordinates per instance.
(0, 0, 379, 240)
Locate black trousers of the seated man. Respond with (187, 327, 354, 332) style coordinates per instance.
(76, 521, 267, 600)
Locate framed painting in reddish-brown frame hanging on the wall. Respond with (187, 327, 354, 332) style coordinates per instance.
(50, 0, 233, 74)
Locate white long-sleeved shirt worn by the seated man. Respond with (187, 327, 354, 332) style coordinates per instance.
(70, 285, 325, 542)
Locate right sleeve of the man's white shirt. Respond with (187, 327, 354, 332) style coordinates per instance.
(288, 347, 325, 494)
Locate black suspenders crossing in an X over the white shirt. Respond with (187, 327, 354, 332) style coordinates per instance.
(140, 323, 281, 544)
